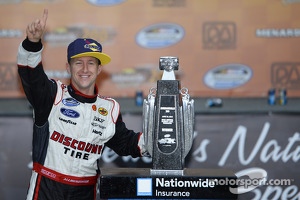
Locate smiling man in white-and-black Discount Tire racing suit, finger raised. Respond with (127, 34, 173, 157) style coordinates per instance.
(18, 10, 146, 200)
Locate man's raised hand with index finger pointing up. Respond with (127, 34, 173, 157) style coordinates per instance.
(26, 9, 48, 42)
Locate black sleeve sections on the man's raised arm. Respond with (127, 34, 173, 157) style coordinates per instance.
(18, 39, 57, 126)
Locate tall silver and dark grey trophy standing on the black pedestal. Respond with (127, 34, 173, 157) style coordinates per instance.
(143, 57, 194, 174)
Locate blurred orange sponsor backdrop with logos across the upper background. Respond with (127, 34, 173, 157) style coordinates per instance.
(0, 0, 300, 98)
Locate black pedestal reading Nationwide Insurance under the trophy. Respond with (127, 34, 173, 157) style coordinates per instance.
(99, 168, 237, 199)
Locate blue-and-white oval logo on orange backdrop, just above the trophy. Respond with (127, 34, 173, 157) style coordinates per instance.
(136, 23, 184, 49)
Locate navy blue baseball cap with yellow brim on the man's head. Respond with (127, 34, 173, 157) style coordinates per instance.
(67, 38, 111, 65)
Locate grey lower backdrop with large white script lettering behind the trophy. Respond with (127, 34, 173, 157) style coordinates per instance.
(0, 114, 300, 200)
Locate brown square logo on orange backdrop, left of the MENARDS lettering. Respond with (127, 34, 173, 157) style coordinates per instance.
(203, 22, 236, 49)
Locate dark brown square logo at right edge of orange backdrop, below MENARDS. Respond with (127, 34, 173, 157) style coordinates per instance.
(271, 62, 300, 89)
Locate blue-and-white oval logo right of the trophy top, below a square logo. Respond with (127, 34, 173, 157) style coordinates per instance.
(204, 64, 252, 89)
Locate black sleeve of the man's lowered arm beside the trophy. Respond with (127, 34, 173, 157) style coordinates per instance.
(106, 114, 141, 158)
